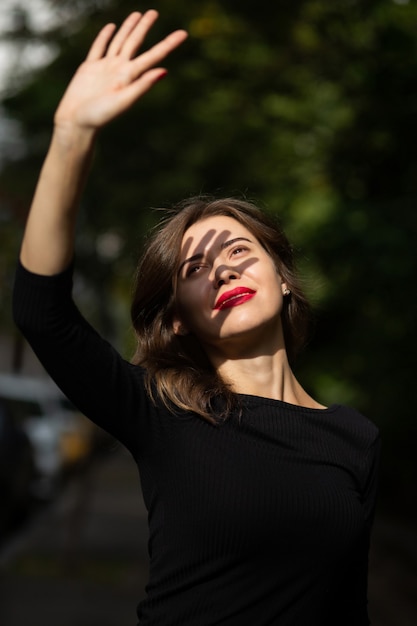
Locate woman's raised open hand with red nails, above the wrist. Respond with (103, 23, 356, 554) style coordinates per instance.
(55, 10, 187, 130)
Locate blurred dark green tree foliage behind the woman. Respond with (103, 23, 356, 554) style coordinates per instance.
(0, 0, 417, 512)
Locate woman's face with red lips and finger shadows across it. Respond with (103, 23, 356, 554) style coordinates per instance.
(174, 215, 286, 351)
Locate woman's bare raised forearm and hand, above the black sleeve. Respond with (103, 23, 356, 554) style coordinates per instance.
(20, 10, 187, 275)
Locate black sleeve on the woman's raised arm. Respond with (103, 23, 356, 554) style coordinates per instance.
(13, 263, 152, 455)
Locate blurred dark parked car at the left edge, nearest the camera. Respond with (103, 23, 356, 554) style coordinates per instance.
(0, 400, 35, 541)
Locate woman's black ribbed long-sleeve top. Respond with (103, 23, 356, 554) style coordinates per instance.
(14, 265, 379, 626)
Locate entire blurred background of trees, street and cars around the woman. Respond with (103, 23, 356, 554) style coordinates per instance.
(0, 0, 417, 626)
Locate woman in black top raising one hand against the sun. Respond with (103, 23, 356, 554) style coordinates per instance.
(14, 11, 378, 626)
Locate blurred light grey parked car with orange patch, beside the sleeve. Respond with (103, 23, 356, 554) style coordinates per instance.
(0, 374, 94, 499)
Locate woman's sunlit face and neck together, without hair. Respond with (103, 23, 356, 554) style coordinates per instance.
(174, 215, 321, 408)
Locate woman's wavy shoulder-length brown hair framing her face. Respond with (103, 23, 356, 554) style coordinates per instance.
(131, 196, 310, 423)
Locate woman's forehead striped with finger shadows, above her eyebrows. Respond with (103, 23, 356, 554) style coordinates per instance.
(181, 215, 255, 257)
